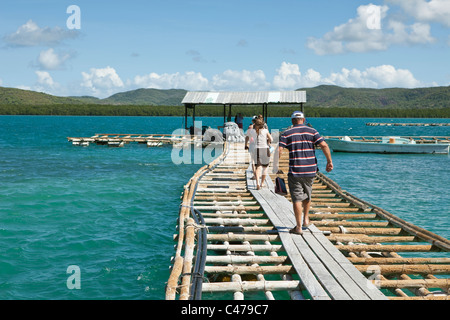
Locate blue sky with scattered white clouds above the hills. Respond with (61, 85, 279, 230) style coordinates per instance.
(0, 0, 450, 98)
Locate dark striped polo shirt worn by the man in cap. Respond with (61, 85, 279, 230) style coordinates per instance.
(279, 124, 324, 177)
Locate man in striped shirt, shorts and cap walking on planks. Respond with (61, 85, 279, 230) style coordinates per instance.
(278, 111, 333, 234)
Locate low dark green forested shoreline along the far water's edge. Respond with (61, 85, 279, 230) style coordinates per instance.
(0, 104, 450, 119)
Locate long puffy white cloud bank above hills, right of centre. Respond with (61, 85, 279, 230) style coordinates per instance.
(273, 62, 420, 90)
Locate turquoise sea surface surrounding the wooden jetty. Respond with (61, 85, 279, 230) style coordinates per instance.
(0, 116, 450, 300)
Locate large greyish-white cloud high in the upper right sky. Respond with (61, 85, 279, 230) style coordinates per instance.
(307, 4, 435, 55)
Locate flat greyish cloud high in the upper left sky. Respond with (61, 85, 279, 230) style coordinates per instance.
(3, 20, 79, 47)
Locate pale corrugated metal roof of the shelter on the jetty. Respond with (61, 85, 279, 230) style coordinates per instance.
(181, 91, 306, 104)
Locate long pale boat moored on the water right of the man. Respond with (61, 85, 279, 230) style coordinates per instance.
(326, 137, 450, 154)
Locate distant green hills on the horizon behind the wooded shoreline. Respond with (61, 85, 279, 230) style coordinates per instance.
(0, 85, 450, 109)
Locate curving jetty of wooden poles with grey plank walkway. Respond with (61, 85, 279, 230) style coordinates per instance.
(166, 143, 450, 300)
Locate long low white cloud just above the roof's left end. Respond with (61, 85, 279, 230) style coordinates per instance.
(134, 71, 209, 90)
